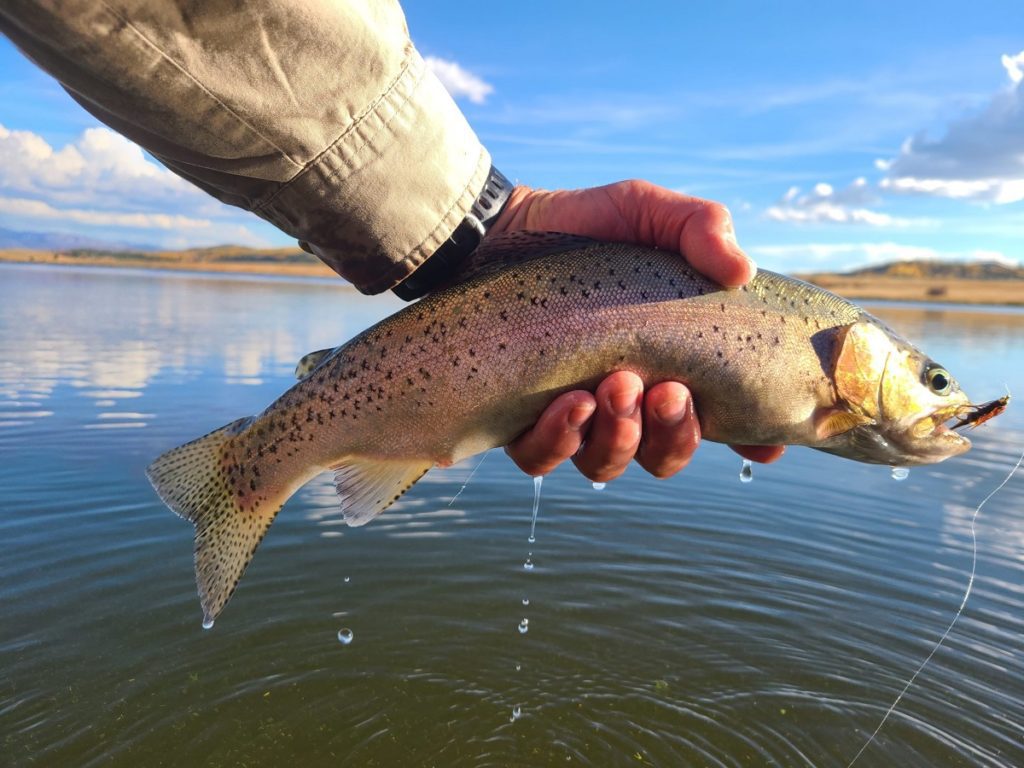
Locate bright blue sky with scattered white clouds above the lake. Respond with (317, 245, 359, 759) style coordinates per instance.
(0, 0, 1024, 271)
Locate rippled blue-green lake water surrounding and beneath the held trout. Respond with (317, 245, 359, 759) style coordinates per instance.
(0, 266, 1024, 768)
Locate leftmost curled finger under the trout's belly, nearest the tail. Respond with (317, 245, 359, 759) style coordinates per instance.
(505, 391, 597, 477)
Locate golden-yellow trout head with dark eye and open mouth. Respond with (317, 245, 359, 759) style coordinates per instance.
(823, 316, 974, 467)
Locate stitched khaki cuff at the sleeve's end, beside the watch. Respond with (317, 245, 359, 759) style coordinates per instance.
(255, 48, 490, 294)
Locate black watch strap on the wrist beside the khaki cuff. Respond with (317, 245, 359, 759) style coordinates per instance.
(391, 166, 513, 301)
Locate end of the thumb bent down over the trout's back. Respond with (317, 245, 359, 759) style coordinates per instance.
(679, 201, 757, 288)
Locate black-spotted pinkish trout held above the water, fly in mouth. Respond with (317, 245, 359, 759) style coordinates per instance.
(146, 233, 1003, 627)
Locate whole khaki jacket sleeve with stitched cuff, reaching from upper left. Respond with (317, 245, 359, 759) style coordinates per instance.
(0, 0, 490, 293)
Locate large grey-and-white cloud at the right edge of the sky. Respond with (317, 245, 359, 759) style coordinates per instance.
(879, 51, 1024, 204)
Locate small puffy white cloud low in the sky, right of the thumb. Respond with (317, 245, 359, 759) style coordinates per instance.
(765, 178, 931, 227)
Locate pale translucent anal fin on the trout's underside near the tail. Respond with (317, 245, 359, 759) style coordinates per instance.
(334, 459, 434, 526)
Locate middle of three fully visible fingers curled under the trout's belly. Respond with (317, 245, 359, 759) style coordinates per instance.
(572, 371, 643, 482)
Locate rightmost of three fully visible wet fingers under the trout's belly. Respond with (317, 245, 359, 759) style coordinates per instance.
(637, 381, 700, 477)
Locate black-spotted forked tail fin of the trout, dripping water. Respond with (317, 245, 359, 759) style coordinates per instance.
(145, 418, 284, 629)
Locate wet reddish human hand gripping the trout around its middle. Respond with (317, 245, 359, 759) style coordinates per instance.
(489, 181, 783, 482)
